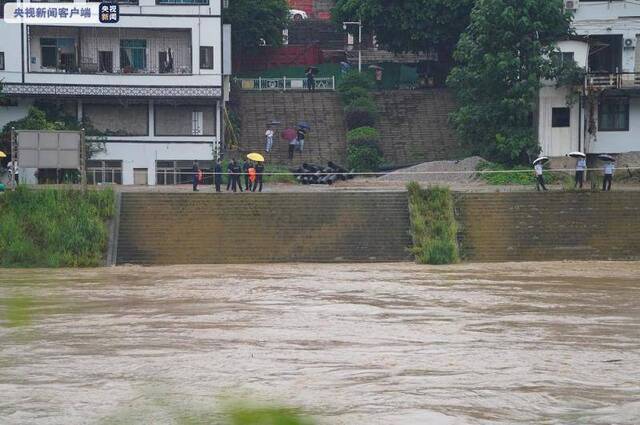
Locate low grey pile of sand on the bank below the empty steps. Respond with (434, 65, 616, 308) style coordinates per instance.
(379, 156, 484, 183)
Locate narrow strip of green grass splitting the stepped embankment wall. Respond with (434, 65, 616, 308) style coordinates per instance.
(407, 182, 460, 264)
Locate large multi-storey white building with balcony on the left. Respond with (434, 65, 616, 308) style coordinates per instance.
(0, 0, 230, 185)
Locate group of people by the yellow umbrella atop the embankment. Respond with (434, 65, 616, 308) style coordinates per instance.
(193, 159, 264, 192)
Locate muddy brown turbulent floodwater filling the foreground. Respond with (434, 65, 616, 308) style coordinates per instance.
(0, 263, 640, 425)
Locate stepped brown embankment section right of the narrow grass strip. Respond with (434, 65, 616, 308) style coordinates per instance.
(456, 192, 640, 262)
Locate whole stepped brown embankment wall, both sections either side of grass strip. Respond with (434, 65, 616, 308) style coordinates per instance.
(117, 192, 640, 264)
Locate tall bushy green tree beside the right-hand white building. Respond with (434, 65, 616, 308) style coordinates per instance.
(448, 0, 575, 164)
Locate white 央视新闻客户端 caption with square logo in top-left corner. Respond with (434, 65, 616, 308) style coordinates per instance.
(4, 2, 120, 25)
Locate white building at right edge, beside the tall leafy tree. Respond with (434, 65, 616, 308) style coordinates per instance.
(538, 0, 640, 161)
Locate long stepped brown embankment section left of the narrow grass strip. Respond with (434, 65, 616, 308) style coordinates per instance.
(117, 192, 411, 265)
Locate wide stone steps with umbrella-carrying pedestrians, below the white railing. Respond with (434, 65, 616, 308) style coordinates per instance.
(233, 90, 347, 166)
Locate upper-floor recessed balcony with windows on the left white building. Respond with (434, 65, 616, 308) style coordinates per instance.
(29, 26, 192, 75)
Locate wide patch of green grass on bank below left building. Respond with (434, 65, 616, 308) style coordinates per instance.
(0, 187, 115, 267)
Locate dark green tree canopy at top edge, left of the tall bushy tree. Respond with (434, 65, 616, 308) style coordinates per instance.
(333, 0, 475, 62)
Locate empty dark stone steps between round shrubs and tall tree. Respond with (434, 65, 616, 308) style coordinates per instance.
(376, 89, 460, 166)
